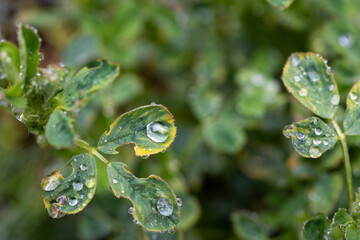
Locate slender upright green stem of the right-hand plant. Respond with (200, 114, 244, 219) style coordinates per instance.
(331, 118, 353, 209)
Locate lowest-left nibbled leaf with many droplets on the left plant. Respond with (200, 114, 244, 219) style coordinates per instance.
(41, 153, 97, 218)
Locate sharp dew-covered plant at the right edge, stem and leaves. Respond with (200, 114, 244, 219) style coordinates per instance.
(282, 53, 360, 239)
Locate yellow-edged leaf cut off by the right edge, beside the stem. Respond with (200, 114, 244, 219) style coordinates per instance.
(344, 81, 360, 135)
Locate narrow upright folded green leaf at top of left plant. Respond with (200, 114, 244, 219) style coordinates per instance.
(17, 24, 40, 88)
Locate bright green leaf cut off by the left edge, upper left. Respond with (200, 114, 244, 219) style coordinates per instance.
(0, 41, 20, 86)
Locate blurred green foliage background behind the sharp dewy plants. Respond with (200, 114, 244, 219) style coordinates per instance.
(0, 0, 360, 240)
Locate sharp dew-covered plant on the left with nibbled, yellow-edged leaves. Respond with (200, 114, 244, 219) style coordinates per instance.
(0, 23, 181, 232)
